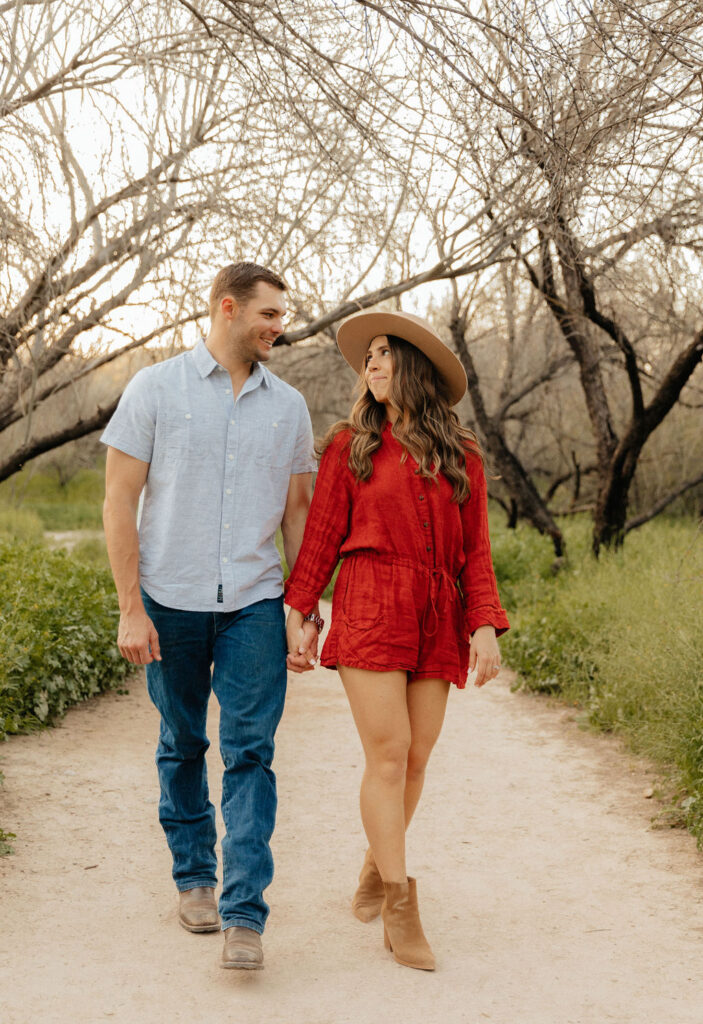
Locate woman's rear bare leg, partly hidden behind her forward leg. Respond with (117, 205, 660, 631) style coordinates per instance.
(404, 679, 449, 828)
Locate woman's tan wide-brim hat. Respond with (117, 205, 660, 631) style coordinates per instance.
(337, 312, 467, 406)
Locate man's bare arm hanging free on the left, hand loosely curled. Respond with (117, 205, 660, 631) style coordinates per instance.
(102, 446, 161, 665)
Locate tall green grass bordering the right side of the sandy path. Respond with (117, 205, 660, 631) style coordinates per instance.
(501, 519, 703, 844)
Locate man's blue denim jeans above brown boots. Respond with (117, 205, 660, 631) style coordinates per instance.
(142, 591, 287, 933)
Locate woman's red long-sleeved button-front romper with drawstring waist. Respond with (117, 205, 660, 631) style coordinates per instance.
(285, 423, 509, 689)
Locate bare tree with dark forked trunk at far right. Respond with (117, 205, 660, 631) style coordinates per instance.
(337, 0, 703, 552)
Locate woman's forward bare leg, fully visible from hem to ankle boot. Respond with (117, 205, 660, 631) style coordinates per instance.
(339, 666, 411, 882)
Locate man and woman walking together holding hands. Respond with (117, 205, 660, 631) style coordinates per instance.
(102, 263, 509, 971)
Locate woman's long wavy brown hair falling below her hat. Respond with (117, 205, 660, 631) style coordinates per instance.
(315, 335, 483, 502)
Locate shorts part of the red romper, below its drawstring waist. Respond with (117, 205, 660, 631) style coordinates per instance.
(320, 552, 470, 689)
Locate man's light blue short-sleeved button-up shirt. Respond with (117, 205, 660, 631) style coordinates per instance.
(101, 342, 316, 611)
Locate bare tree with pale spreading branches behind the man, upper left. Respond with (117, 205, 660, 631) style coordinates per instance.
(0, 0, 433, 479)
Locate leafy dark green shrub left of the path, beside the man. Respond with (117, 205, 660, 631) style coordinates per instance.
(0, 542, 130, 738)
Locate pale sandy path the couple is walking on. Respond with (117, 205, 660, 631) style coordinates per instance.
(0, 598, 703, 1024)
